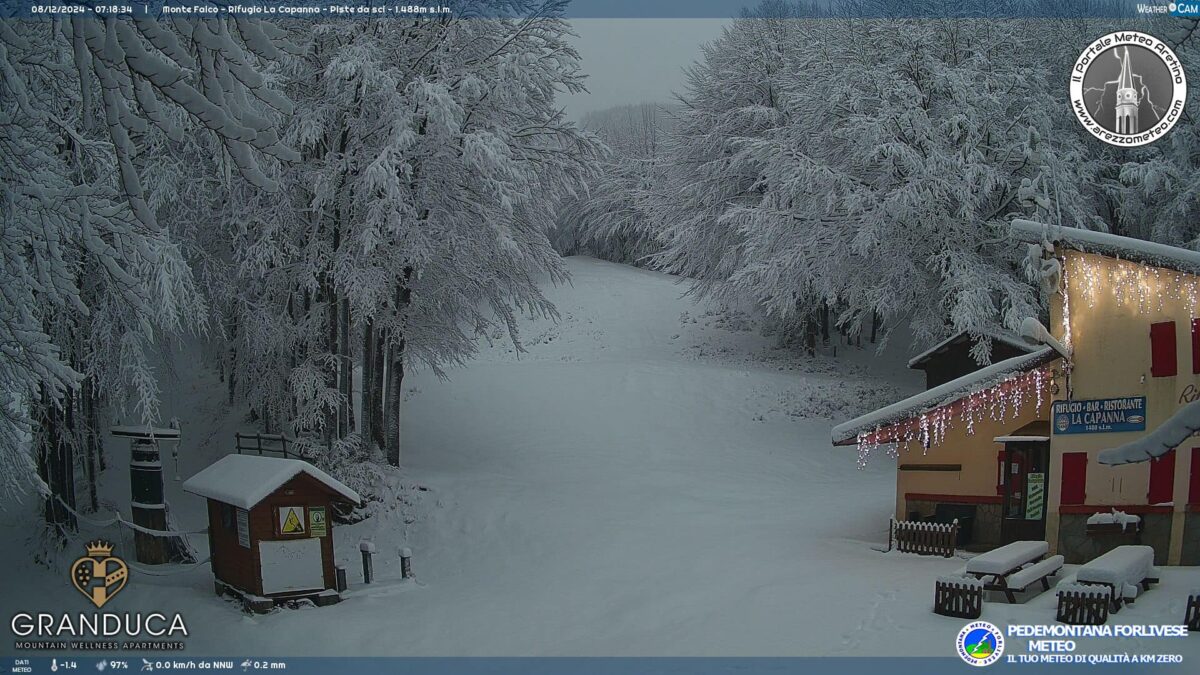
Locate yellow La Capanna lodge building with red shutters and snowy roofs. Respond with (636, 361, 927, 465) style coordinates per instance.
(833, 220, 1200, 565)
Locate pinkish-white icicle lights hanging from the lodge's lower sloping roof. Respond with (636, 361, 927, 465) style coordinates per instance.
(857, 366, 1054, 468)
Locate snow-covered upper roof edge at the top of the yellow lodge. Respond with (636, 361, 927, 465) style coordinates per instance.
(1010, 219, 1200, 274)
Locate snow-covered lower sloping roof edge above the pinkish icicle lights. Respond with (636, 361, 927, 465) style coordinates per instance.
(832, 347, 1058, 446)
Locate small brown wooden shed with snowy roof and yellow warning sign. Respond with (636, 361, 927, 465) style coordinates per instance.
(184, 454, 362, 610)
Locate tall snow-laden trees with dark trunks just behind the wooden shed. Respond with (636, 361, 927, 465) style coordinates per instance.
(207, 2, 596, 478)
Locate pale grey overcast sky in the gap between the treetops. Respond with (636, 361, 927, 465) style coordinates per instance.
(562, 18, 728, 119)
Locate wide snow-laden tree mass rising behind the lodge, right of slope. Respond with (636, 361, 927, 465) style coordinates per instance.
(643, 4, 1103, 359)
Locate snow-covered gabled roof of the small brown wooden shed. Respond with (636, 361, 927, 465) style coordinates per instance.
(184, 454, 362, 510)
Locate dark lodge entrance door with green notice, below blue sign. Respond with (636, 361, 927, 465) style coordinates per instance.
(1000, 441, 1050, 544)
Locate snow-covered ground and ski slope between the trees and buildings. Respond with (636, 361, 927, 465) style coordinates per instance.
(0, 258, 1200, 659)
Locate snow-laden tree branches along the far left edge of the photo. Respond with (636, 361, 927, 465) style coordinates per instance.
(0, 14, 294, 528)
